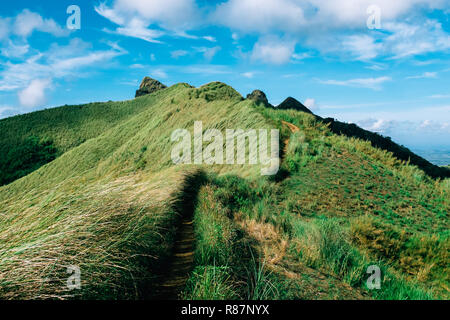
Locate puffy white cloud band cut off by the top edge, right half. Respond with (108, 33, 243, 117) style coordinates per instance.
(214, 0, 449, 33)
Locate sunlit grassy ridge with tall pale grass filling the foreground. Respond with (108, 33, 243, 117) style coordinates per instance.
(0, 83, 450, 299)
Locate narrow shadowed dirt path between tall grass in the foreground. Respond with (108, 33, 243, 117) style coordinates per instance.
(158, 218, 195, 300)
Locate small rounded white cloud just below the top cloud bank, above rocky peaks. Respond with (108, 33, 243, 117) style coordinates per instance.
(251, 37, 295, 65)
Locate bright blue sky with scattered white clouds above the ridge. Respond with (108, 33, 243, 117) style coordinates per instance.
(0, 0, 450, 159)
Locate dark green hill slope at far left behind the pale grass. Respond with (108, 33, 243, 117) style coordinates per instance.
(0, 97, 163, 186)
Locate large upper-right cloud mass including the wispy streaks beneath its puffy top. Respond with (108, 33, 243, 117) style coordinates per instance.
(213, 0, 450, 60)
